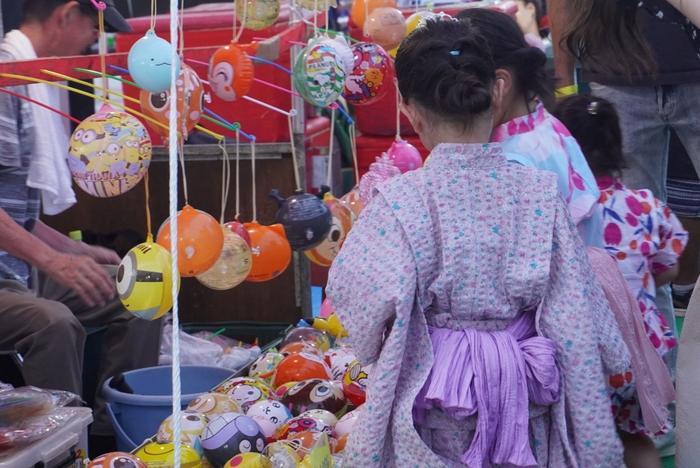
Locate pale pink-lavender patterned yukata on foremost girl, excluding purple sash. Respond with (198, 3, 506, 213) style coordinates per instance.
(326, 144, 629, 468)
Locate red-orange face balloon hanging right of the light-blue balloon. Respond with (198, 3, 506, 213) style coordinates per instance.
(208, 42, 253, 101)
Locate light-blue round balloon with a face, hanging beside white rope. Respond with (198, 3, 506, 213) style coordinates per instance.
(127, 29, 180, 94)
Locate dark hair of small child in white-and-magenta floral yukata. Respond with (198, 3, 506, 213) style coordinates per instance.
(554, 95, 627, 177)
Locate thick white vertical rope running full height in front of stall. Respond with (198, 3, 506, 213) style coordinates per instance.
(168, 0, 182, 460)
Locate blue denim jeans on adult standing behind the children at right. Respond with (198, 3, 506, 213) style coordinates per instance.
(591, 83, 700, 380)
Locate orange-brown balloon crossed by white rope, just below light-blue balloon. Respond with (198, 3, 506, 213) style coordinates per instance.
(140, 64, 209, 143)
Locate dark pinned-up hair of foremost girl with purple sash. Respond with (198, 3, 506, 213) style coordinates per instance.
(396, 19, 496, 130)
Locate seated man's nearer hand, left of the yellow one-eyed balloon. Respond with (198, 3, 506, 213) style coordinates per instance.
(44, 252, 119, 307)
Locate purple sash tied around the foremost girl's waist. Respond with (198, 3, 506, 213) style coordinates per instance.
(414, 311, 560, 467)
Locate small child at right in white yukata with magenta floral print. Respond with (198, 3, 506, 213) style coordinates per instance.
(555, 96, 688, 468)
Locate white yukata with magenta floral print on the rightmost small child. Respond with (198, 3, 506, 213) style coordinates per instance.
(597, 177, 688, 433)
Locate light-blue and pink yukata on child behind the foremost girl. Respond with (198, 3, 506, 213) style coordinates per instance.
(491, 103, 602, 243)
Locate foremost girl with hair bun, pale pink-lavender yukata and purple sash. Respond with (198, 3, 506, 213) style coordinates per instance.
(326, 16, 630, 468)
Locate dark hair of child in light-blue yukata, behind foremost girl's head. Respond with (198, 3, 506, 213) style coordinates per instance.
(457, 8, 555, 108)
